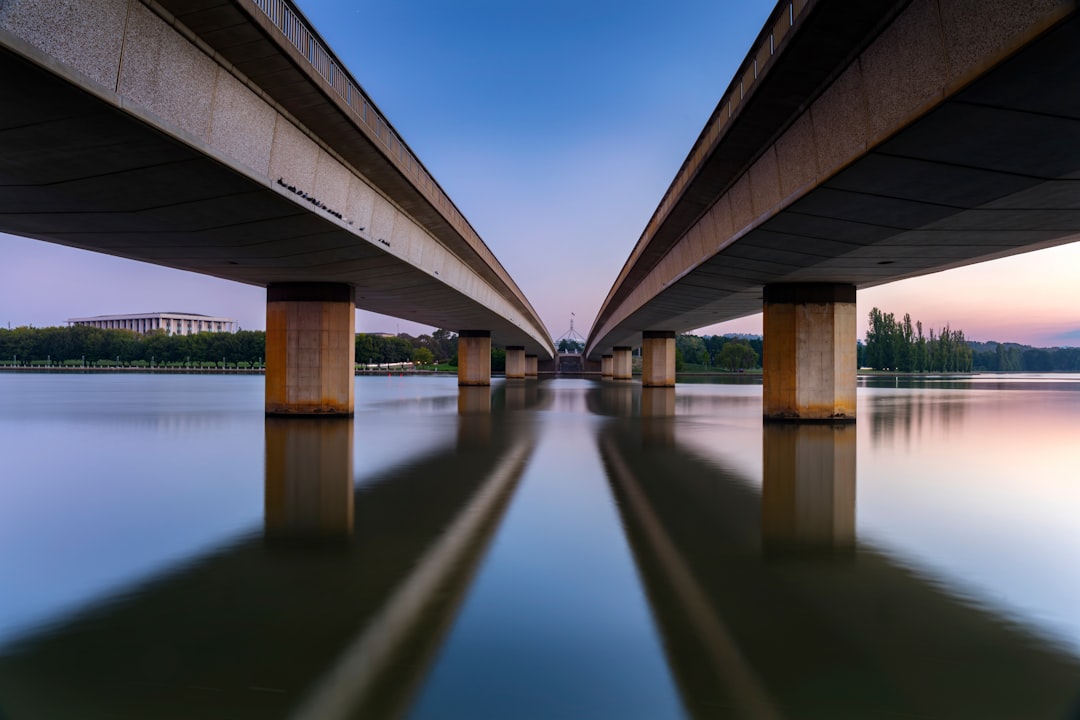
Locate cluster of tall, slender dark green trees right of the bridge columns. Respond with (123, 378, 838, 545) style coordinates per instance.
(859, 308, 974, 372)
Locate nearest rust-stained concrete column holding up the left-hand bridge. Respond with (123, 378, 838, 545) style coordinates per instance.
(266, 283, 356, 416)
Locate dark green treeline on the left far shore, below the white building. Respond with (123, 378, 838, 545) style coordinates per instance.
(0, 325, 473, 369)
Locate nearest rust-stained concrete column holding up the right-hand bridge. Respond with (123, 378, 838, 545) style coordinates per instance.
(761, 283, 856, 422)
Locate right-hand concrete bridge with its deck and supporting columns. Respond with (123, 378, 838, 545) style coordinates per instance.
(585, 0, 1080, 421)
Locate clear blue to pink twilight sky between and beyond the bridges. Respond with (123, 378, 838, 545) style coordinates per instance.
(0, 0, 1080, 347)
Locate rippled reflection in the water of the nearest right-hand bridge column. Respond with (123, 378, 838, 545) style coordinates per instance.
(761, 423, 855, 555)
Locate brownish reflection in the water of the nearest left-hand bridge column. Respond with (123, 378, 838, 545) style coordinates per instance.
(264, 417, 355, 542)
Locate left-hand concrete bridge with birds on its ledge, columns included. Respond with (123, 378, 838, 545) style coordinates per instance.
(0, 0, 554, 415)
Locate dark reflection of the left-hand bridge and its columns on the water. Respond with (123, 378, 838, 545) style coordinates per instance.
(0, 395, 534, 720)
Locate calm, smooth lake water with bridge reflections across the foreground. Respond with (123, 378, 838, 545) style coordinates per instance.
(0, 373, 1080, 720)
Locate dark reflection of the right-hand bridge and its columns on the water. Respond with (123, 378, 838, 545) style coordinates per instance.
(589, 385, 1080, 719)
